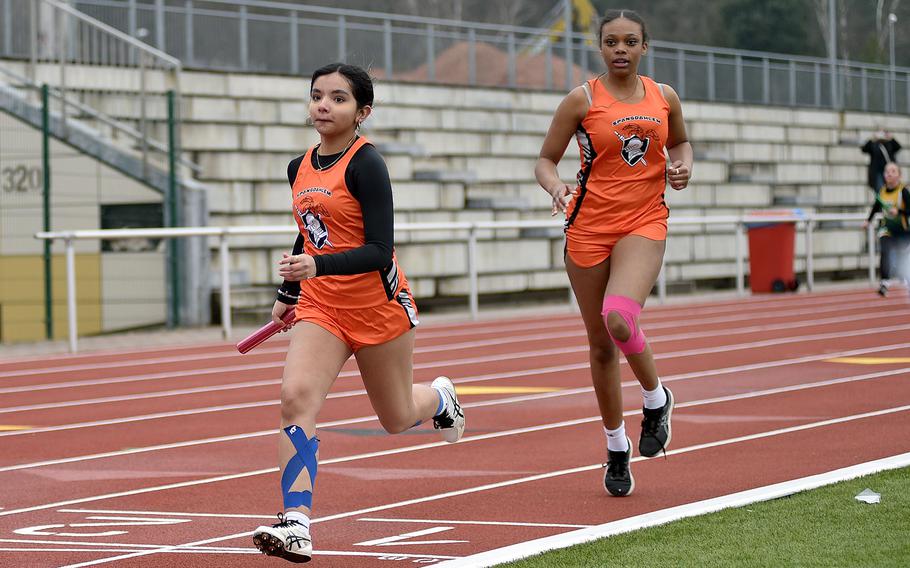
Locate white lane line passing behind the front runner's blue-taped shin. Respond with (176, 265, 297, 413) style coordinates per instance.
(0, 378, 910, 517)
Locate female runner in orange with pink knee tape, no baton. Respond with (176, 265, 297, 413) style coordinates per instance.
(535, 10, 692, 496)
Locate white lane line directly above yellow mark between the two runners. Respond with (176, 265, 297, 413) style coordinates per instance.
(0, 318, 910, 414)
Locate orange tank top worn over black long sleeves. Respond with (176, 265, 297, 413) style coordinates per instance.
(291, 137, 408, 309)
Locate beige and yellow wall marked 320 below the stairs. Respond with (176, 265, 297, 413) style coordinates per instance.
(0, 107, 165, 342)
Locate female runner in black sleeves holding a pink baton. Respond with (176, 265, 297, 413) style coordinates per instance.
(253, 63, 465, 562)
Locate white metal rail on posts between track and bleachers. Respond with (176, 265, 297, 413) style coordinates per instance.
(35, 211, 875, 353)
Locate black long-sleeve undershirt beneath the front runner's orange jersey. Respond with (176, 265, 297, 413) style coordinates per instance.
(278, 140, 395, 304)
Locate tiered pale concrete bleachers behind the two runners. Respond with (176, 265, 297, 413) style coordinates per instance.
(5, 63, 910, 316)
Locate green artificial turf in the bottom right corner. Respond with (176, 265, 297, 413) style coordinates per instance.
(501, 468, 910, 568)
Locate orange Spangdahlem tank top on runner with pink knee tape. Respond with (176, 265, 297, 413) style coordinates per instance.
(566, 77, 670, 240)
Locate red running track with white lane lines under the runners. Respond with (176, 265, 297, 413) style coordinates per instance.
(0, 290, 910, 568)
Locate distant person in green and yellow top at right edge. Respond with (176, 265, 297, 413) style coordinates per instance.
(863, 162, 910, 296)
